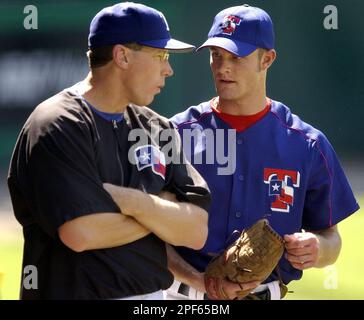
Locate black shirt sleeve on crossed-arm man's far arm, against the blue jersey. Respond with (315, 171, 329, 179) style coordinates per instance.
(169, 124, 211, 211)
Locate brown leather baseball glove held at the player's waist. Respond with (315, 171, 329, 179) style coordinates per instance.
(205, 219, 284, 300)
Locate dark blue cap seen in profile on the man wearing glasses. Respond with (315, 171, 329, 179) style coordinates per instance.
(88, 2, 195, 52)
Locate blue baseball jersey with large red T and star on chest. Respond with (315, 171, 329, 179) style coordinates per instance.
(171, 101, 359, 284)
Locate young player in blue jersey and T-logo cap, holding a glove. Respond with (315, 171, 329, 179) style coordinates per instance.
(168, 5, 359, 299)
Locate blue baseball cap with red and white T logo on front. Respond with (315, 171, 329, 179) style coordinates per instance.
(197, 4, 274, 57)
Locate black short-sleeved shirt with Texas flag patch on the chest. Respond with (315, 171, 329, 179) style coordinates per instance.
(8, 88, 210, 299)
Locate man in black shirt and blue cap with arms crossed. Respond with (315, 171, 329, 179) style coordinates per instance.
(8, 3, 210, 299)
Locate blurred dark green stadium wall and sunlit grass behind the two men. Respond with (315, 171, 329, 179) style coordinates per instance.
(0, 0, 364, 299)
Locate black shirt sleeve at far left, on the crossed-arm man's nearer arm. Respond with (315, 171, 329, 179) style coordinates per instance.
(13, 110, 120, 237)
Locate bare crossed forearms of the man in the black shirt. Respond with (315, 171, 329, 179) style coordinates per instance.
(58, 184, 207, 252)
